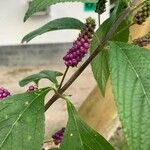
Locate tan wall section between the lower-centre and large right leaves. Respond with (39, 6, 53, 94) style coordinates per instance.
(79, 80, 119, 139)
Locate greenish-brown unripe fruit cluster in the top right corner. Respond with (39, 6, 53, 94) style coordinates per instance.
(134, 1, 150, 25)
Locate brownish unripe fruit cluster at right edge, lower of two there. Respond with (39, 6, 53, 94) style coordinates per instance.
(133, 32, 150, 47)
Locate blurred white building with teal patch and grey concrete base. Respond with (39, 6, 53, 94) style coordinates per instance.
(0, 0, 113, 66)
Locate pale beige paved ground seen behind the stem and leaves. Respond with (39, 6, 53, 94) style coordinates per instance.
(0, 65, 96, 149)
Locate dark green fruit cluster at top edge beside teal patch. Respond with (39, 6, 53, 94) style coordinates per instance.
(95, 0, 107, 14)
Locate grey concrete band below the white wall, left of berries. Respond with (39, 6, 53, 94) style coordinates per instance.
(0, 43, 71, 66)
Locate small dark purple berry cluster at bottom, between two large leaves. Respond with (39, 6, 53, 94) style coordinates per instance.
(52, 128, 65, 145)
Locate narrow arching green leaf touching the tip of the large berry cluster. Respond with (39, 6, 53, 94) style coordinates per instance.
(22, 17, 84, 43)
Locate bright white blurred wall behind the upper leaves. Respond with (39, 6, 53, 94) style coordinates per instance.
(0, 0, 109, 45)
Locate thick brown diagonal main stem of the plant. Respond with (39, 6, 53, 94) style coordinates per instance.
(45, 7, 131, 111)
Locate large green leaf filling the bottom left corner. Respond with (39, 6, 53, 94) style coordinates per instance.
(0, 88, 49, 150)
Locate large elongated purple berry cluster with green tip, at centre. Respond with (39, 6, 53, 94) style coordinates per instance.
(63, 17, 96, 67)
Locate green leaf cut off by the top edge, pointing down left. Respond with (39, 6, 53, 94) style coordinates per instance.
(24, 0, 98, 21)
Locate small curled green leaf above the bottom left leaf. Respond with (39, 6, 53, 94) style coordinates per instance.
(19, 70, 63, 87)
